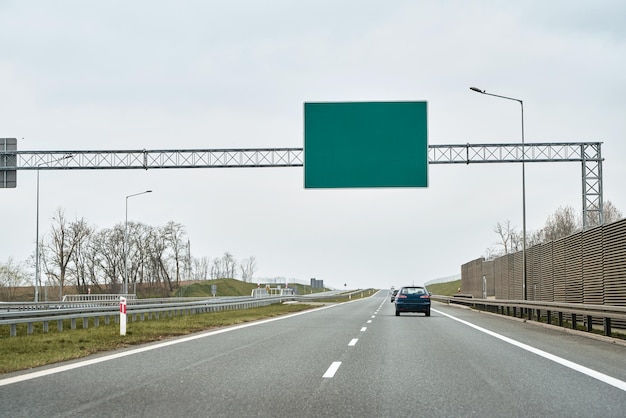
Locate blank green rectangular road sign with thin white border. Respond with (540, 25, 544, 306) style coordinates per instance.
(304, 102, 428, 188)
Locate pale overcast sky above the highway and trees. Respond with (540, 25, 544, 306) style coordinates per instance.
(0, 0, 626, 288)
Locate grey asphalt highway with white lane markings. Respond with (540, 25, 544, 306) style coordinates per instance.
(0, 291, 626, 418)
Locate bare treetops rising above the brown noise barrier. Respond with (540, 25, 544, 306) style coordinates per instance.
(485, 201, 624, 259)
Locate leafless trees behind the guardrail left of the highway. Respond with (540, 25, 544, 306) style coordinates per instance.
(0, 209, 256, 300)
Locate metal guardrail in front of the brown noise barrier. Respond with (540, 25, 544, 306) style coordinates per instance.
(431, 295, 626, 337)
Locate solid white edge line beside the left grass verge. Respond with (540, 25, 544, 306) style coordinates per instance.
(0, 302, 342, 386)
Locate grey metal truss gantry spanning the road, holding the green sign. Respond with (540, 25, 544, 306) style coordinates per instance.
(0, 142, 603, 229)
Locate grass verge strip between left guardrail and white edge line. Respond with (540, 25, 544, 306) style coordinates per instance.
(0, 304, 312, 374)
